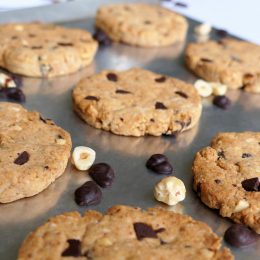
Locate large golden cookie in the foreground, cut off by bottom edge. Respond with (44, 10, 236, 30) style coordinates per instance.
(18, 206, 233, 260)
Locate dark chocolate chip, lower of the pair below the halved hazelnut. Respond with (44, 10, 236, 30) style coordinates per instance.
(75, 181, 102, 206)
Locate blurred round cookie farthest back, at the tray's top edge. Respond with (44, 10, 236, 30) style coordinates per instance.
(96, 3, 188, 47)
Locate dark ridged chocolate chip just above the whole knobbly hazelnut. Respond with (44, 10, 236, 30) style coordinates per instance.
(146, 154, 173, 175)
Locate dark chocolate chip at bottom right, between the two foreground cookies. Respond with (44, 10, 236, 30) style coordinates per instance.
(224, 224, 259, 247)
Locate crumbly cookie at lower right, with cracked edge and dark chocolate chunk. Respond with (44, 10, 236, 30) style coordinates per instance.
(193, 132, 260, 234)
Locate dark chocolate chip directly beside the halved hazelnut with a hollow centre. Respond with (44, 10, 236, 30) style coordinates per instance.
(88, 163, 115, 188)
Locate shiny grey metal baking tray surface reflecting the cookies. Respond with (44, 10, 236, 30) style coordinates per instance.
(0, 2, 260, 260)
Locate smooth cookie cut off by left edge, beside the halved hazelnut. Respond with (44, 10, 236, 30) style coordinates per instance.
(0, 102, 71, 203)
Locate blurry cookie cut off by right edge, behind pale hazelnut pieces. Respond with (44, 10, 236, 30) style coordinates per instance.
(186, 39, 260, 93)
